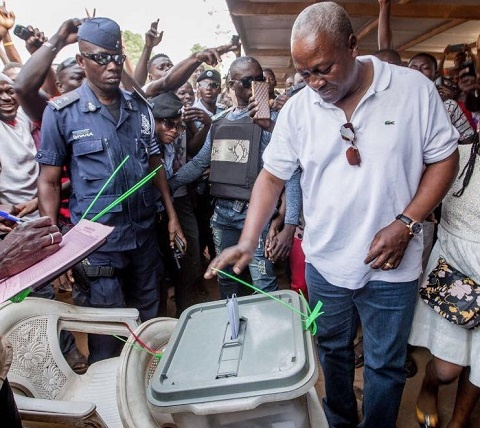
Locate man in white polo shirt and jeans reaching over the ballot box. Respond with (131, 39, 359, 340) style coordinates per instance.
(206, 2, 458, 428)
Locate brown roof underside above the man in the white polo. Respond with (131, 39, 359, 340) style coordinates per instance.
(226, 0, 480, 86)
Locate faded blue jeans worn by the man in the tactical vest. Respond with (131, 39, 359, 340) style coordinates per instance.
(211, 198, 278, 299)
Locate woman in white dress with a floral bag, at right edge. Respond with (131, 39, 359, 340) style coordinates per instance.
(409, 121, 480, 428)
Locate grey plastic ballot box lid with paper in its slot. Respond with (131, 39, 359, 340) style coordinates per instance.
(147, 290, 318, 413)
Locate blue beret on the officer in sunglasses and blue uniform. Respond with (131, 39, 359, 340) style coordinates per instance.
(77, 18, 122, 51)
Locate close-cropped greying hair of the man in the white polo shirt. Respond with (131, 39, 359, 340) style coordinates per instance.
(291, 2, 353, 47)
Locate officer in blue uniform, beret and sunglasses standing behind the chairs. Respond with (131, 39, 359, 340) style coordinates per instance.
(37, 18, 183, 363)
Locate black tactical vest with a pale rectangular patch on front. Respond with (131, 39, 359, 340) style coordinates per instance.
(210, 117, 262, 200)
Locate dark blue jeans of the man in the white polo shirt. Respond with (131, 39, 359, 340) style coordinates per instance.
(305, 263, 418, 428)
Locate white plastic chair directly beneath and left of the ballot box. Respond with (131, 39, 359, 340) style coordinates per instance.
(117, 318, 178, 428)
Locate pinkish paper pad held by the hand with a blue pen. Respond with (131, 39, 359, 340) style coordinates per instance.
(0, 220, 113, 303)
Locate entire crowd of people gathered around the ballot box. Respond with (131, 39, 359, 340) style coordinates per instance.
(0, 0, 480, 428)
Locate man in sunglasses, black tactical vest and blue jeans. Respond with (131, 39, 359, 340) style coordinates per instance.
(170, 57, 301, 298)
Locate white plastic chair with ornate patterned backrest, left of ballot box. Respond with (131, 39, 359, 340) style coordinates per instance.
(0, 298, 139, 428)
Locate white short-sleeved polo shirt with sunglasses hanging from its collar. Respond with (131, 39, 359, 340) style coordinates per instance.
(263, 56, 458, 289)
